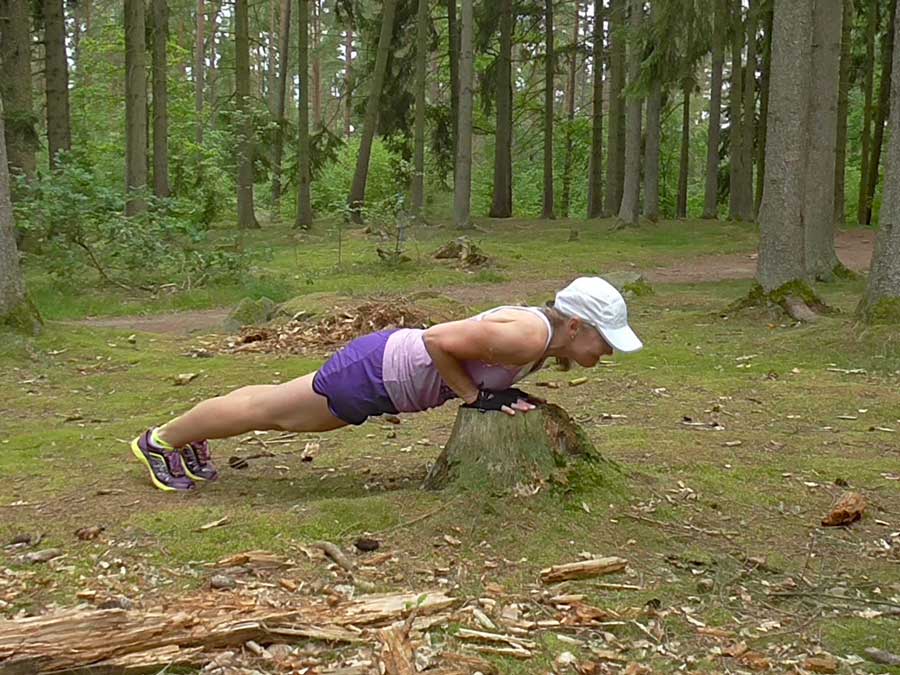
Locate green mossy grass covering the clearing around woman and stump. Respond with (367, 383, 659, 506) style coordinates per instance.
(0, 221, 900, 673)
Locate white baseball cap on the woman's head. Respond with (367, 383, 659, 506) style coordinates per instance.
(553, 277, 644, 354)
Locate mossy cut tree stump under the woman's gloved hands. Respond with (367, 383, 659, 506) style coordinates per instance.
(424, 403, 618, 491)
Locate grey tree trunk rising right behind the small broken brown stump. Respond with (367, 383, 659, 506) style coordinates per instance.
(451, 0, 475, 229)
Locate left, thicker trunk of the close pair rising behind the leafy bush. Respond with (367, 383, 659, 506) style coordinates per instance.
(125, 0, 147, 216)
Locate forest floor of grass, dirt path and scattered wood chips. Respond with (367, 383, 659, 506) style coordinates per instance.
(0, 221, 900, 675)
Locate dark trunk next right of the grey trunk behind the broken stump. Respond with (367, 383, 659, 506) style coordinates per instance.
(489, 0, 513, 218)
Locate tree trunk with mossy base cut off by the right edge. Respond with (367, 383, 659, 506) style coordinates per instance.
(859, 0, 900, 323)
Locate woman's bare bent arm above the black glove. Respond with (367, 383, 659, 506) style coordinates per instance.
(423, 315, 547, 403)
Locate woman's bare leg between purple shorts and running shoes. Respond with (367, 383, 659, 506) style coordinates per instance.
(157, 373, 347, 448)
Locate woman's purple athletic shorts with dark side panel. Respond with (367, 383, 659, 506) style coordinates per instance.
(313, 330, 397, 424)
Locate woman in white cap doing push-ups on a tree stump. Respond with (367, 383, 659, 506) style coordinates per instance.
(131, 277, 643, 490)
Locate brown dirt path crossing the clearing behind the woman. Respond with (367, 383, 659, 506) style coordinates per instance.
(63, 229, 875, 335)
